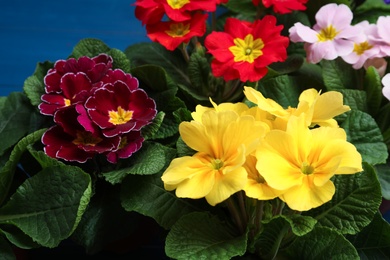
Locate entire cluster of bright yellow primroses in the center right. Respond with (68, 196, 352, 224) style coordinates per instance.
(162, 87, 362, 211)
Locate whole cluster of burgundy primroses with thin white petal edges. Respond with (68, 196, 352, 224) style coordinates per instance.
(39, 54, 157, 163)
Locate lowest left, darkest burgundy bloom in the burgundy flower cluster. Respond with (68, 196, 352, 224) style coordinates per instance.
(42, 105, 120, 163)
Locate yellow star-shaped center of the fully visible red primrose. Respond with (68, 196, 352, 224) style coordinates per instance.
(229, 34, 264, 63)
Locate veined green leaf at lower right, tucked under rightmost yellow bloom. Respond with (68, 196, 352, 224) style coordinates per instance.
(306, 163, 382, 234)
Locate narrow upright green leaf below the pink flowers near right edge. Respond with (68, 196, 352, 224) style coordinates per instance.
(364, 66, 383, 116)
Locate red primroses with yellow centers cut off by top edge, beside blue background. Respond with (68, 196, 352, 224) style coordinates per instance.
(135, 0, 219, 51)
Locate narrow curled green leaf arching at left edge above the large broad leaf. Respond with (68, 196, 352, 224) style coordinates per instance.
(0, 129, 45, 205)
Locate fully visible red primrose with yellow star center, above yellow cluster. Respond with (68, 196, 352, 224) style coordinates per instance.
(205, 15, 289, 82)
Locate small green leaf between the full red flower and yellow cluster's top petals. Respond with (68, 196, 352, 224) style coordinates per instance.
(258, 75, 301, 108)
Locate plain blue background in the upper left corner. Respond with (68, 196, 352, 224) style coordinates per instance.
(0, 0, 149, 96)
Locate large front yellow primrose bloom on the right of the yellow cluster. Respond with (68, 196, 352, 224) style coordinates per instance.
(256, 114, 362, 211)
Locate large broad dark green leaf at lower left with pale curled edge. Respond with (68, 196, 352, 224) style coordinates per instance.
(0, 166, 91, 248)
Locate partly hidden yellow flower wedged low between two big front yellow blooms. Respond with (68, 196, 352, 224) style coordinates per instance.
(243, 155, 283, 200)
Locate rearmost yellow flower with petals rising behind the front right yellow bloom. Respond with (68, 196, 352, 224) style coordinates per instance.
(244, 87, 350, 130)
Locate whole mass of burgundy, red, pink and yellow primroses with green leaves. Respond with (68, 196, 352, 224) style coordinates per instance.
(0, 0, 390, 259)
